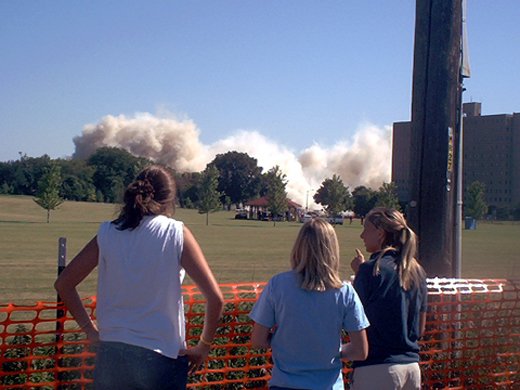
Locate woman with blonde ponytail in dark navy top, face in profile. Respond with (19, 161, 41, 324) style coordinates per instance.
(351, 208, 427, 390)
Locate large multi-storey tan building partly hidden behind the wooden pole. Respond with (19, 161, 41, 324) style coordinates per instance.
(392, 103, 520, 215)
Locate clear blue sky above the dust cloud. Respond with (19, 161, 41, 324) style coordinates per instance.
(0, 0, 520, 165)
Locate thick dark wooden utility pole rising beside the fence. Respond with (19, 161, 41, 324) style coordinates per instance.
(407, 0, 462, 277)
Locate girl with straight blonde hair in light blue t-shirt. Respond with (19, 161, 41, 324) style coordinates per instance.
(250, 219, 369, 390)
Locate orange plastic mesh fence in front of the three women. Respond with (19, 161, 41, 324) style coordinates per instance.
(0, 279, 520, 389)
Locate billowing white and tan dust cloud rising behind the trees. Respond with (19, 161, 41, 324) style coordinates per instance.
(74, 113, 391, 206)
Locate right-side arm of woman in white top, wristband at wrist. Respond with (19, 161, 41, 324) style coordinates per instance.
(181, 226, 224, 372)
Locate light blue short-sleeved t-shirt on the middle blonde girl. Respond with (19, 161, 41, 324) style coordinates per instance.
(249, 271, 369, 390)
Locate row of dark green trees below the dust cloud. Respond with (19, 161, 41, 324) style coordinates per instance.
(0, 147, 400, 222)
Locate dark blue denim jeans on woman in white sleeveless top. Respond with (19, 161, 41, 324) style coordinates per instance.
(94, 341, 188, 390)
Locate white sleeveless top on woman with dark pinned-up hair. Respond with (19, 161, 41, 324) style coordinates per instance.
(96, 215, 185, 358)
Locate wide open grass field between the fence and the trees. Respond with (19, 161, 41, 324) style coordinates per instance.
(0, 196, 520, 304)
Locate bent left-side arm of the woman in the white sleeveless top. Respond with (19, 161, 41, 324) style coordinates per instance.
(54, 237, 99, 342)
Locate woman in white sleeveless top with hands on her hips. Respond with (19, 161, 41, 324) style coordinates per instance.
(54, 166, 223, 389)
